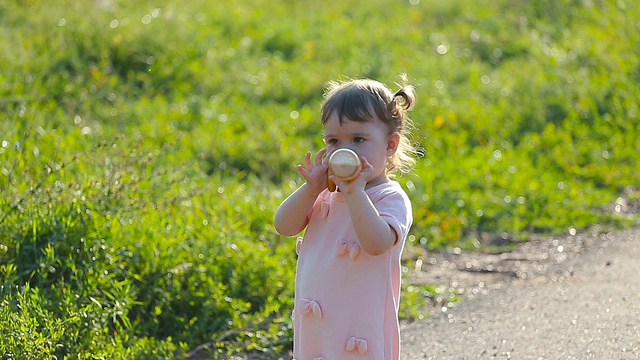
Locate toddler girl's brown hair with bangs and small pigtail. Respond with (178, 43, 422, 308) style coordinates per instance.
(321, 76, 418, 174)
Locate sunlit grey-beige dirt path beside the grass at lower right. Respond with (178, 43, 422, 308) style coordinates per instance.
(402, 229, 640, 360)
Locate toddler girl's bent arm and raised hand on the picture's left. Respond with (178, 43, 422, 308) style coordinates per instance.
(274, 148, 328, 236)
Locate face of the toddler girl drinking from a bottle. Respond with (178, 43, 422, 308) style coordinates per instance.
(324, 112, 399, 188)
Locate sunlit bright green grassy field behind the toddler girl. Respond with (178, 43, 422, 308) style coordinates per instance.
(0, 0, 640, 359)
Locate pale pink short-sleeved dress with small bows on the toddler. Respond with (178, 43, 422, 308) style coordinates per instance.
(293, 181, 413, 360)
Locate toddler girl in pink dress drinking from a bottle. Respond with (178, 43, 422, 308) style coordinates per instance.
(275, 79, 415, 360)
